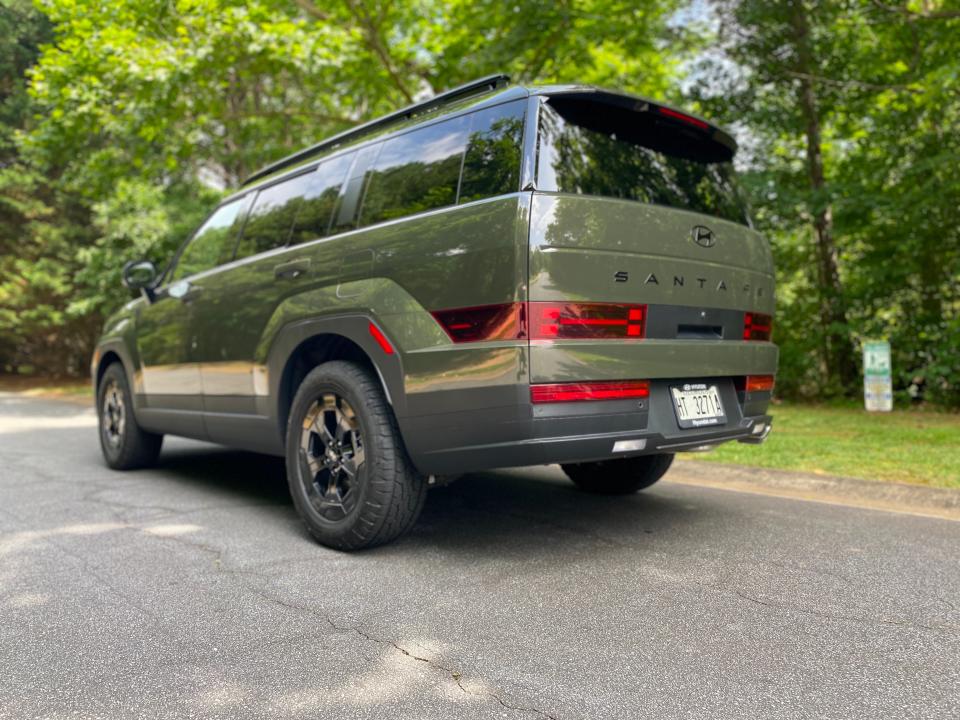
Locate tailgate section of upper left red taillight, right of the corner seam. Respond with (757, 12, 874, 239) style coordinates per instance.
(530, 302, 647, 340)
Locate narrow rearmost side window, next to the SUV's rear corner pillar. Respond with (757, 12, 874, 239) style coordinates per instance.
(459, 100, 526, 203)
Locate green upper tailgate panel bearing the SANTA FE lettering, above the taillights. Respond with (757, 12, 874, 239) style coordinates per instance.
(530, 193, 774, 314)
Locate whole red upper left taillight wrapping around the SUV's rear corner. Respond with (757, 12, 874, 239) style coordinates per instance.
(432, 302, 647, 343)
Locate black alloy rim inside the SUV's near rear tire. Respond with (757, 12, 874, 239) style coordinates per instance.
(299, 392, 364, 522)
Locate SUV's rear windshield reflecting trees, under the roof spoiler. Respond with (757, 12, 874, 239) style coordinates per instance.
(537, 96, 749, 225)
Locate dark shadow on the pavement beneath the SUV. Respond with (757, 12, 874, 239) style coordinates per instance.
(150, 447, 712, 557)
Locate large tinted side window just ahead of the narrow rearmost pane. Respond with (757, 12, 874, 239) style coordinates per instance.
(360, 116, 470, 225)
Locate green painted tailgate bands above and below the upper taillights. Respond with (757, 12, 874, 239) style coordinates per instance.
(530, 193, 778, 383)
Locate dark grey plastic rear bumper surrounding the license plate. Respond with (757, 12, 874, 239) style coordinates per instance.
(401, 378, 771, 475)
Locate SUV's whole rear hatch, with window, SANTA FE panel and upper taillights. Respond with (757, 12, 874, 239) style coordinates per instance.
(528, 92, 777, 390)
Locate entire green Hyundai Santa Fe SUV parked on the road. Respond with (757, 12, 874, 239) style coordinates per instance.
(92, 76, 777, 549)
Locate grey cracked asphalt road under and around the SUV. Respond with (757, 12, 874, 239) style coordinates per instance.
(0, 396, 960, 720)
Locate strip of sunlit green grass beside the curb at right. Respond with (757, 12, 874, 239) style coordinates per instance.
(686, 404, 960, 488)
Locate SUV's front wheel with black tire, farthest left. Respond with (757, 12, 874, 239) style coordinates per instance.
(97, 362, 163, 470)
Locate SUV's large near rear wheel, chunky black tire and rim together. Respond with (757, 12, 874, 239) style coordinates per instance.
(286, 360, 427, 550)
